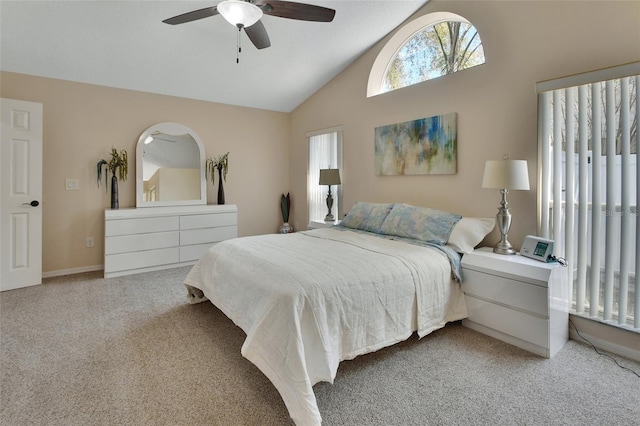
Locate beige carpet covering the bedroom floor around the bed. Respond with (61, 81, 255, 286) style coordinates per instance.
(0, 268, 640, 426)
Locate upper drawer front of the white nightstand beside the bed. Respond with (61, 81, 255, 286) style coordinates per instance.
(462, 269, 549, 317)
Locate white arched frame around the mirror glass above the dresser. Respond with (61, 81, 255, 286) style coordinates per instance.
(136, 122, 207, 207)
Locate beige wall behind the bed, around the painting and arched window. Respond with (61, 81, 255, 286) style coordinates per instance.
(290, 0, 640, 247)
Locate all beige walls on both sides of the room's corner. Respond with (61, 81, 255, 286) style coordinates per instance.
(0, 0, 640, 273)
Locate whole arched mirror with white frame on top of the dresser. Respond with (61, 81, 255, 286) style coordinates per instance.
(136, 123, 207, 207)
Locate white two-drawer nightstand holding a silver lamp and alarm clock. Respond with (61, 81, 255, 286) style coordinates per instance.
(462, 247, 569, 358)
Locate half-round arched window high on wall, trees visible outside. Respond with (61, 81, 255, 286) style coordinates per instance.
(367, 12, 485, 96)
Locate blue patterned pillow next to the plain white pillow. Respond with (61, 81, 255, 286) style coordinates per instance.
(381, 204, 462, 244)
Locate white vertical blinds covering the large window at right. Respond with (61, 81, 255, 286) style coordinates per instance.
(537, 62, 640, 329)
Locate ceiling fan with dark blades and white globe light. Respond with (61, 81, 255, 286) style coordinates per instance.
(162, 0, 336, 54)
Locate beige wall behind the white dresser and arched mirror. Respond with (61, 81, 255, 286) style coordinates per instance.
(0, 72, 289, 274)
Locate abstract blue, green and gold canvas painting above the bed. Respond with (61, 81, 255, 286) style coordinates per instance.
(375, 112, 458, 176)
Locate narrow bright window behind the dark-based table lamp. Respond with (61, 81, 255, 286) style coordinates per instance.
(307, 127, 342, 222)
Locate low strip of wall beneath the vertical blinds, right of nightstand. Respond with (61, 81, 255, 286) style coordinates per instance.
(569, 314, 640, 362)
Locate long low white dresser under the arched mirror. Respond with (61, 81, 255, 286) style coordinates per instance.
(104, 205, 238, 278)
